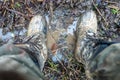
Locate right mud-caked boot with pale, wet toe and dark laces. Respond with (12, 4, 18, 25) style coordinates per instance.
(75, 10, 97, 64)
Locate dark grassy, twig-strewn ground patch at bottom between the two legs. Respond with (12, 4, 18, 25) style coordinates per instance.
(43, 54, 84, 80)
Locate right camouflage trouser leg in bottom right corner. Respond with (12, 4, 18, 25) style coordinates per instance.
(88, 43, 120, 80)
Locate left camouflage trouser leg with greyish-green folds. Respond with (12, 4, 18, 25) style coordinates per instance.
(0, 42, 44, 80)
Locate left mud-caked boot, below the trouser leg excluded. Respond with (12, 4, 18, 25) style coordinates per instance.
(26, 15, 47, 71)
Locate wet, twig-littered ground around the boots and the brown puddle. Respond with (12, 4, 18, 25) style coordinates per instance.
(0, 0, 120, 80)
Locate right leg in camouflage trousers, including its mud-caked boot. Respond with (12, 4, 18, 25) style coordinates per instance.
(75, 11, 120, 80)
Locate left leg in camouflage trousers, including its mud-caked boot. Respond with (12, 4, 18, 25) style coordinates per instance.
(0, 15, 47, 80)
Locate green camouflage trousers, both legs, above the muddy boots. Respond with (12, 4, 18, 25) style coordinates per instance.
(0, 43, 120, 80)
